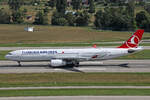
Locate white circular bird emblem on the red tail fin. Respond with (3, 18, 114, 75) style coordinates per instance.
(126, 35, 140, 48)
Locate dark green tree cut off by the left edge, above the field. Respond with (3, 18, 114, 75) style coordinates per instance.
(0, 9, 10, 24)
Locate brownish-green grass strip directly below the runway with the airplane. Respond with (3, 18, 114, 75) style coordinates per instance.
(0, 73, 150, 87)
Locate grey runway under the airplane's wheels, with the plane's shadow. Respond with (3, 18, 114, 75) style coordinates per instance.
(0, 60, 150, 73)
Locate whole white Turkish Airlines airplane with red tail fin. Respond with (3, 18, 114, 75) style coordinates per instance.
(5, 29, 144, 67)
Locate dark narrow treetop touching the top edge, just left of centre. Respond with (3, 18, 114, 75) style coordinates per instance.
(56, 0, 67, 13)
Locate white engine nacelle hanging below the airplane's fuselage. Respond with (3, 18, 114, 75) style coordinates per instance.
(51, 59, 66, 67)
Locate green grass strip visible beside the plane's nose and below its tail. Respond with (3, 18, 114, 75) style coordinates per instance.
(0, 50, 150, 60)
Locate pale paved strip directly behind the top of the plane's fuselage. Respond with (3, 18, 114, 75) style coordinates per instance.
(0, 46, 150, 51)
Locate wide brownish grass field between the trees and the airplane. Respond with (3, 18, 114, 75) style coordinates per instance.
(0, 24, 150, 44)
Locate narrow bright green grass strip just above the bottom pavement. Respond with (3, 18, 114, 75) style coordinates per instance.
(0, 89, 150, 97)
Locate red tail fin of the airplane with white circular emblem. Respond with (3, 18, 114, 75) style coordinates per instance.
(118, 30, 144, 48)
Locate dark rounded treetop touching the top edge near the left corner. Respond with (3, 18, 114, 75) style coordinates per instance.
(8, 0, 24, 11)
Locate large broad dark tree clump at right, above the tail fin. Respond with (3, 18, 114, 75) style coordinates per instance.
(94, 8, 135, 31)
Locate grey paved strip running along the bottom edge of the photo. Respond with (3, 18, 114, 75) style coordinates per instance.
(0, 96, 150, 100)
